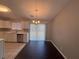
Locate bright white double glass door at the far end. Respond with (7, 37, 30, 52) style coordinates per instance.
(30, 24, 46, 41)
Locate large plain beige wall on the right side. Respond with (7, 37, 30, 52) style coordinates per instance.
(48, 0, 79, 59)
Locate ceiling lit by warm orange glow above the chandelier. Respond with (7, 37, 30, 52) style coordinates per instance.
(0, 0, 69, 21)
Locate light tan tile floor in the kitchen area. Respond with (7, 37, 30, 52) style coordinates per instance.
(4, 43, 26, 59)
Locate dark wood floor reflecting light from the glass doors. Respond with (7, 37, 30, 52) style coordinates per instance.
(15, 41, 64, 59)
